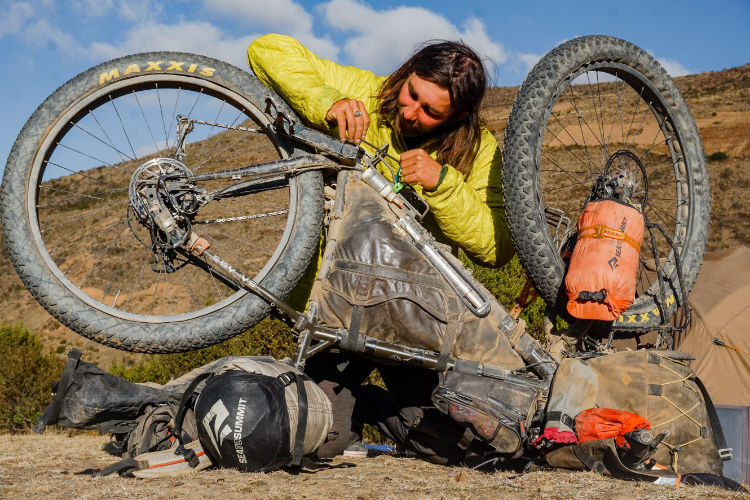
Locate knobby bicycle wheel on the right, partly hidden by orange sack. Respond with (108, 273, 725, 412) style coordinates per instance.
(503, 36, 710, 331)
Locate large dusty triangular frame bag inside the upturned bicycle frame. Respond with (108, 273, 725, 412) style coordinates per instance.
(310, 172, 524, 369)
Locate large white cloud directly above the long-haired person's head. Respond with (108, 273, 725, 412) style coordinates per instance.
(319, 0, 508, 74)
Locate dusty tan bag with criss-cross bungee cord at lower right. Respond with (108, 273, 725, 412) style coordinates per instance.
(545, 350, 725, 474)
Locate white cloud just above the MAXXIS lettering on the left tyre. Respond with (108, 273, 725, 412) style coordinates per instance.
(89, 22, 258, 68)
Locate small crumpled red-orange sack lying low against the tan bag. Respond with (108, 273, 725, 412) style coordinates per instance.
(576, 408, 651, 447)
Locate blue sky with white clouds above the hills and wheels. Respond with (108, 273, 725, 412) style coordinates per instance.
(0, 0, 750, 168)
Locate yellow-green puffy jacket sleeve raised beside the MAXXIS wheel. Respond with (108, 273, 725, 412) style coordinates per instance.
(247, 34, 378, 130)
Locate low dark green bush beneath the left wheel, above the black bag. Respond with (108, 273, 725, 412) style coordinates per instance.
(109, 318, 295, 384)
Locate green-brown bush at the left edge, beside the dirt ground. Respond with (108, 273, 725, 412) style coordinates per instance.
(0, 325, 65, 431)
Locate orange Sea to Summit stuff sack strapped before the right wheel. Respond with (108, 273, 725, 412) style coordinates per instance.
(565, 199, 644, 321)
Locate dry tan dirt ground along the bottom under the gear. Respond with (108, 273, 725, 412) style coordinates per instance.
(0, 433, 742, 500)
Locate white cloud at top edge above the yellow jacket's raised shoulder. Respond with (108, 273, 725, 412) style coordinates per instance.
(204, 0, 339, 60)
